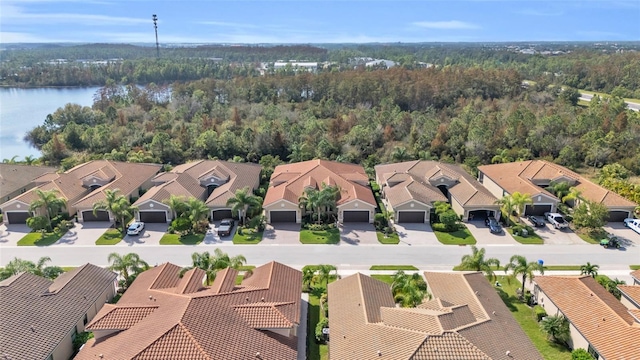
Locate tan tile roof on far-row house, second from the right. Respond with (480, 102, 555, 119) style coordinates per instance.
(375, 160, 498, 207)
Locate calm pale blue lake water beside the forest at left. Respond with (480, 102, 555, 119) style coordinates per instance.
(0, 87, 99, 161)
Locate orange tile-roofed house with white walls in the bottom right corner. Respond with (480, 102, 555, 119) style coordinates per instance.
(533, 275, 640, 360)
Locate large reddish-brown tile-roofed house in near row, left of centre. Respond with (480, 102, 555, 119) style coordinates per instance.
(75, 262, 302, 360)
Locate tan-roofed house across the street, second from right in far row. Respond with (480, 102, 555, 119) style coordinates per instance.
(375, 160, 500, 223)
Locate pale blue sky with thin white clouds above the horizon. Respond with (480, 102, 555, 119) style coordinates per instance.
(0, 0, 640, 43)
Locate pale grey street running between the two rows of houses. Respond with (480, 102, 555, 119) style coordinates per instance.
(0, 244, 640, 270)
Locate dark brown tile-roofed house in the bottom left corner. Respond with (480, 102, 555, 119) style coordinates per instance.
(0, 264, 116, 360)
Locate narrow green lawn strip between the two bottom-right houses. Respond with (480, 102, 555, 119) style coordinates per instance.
(496, 276, 571, 360)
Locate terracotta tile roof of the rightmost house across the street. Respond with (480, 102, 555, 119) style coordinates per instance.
(478, 160, 636, 208)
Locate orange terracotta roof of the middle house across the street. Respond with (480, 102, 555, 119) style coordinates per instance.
(263, 160, 376, 207)
